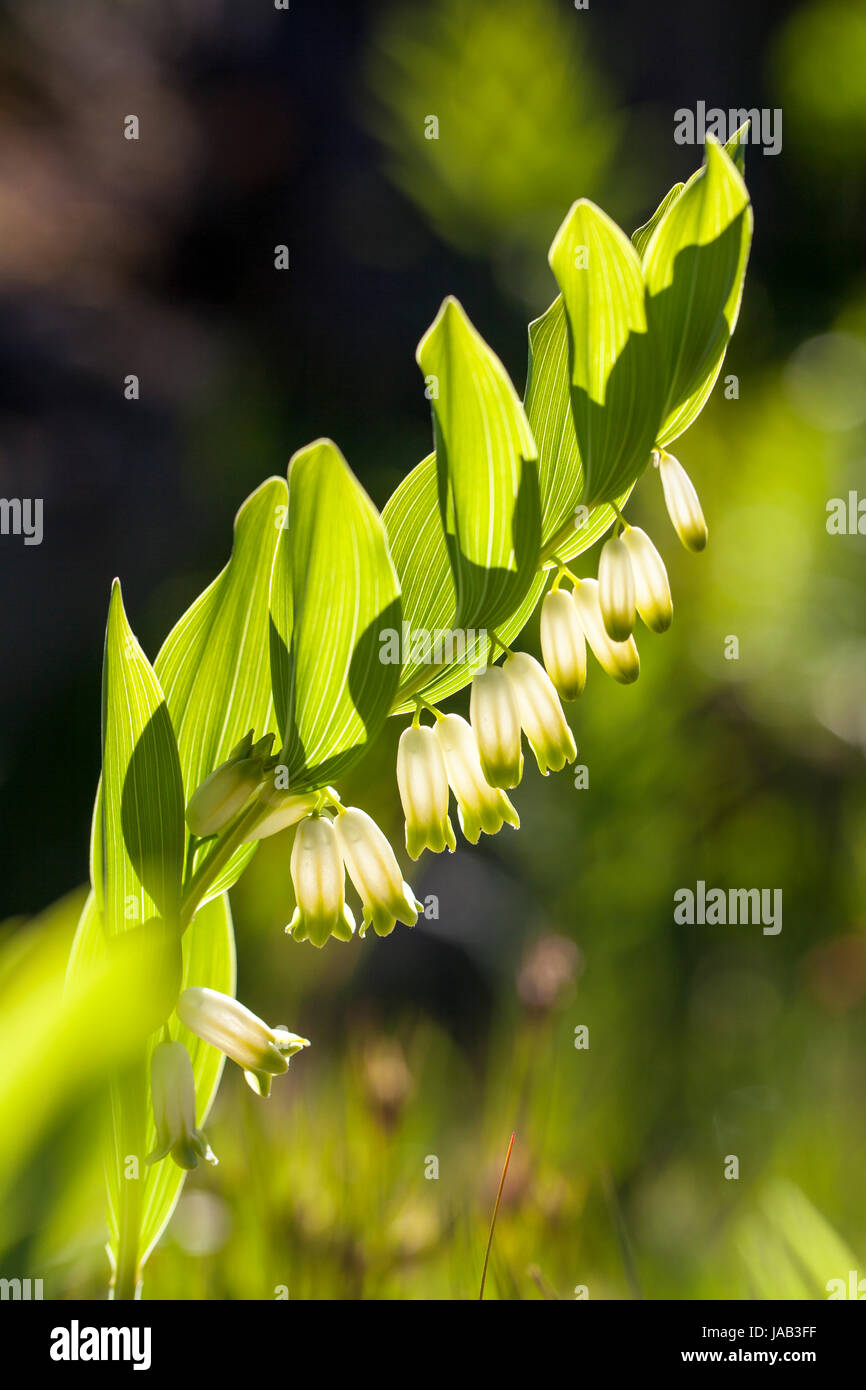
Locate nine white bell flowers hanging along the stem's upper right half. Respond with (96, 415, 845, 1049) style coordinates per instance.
(398, 450, 706, 859)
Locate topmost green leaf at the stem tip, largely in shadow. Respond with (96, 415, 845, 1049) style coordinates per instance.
(644, 140, 752, 445)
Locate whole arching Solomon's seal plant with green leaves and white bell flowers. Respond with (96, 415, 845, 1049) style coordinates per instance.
(70, 128, 752, 1298)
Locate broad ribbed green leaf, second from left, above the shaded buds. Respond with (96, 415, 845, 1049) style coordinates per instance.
(154, 478, 286, 898)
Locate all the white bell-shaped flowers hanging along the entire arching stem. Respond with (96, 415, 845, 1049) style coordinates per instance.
(149, 433, 708, 1168)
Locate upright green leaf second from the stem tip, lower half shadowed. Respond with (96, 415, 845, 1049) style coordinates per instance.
(549, 199, 664, 506)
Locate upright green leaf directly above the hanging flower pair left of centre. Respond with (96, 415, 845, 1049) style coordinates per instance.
(271, 439, 402, 791)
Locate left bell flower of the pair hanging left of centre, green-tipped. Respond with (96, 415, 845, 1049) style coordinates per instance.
(286, 816, 354, 947)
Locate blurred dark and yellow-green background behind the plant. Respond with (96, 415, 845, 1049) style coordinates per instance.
(0, 0, 866, 1298)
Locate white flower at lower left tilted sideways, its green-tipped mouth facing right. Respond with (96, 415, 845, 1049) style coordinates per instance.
(178, 986, 310, 1095)
